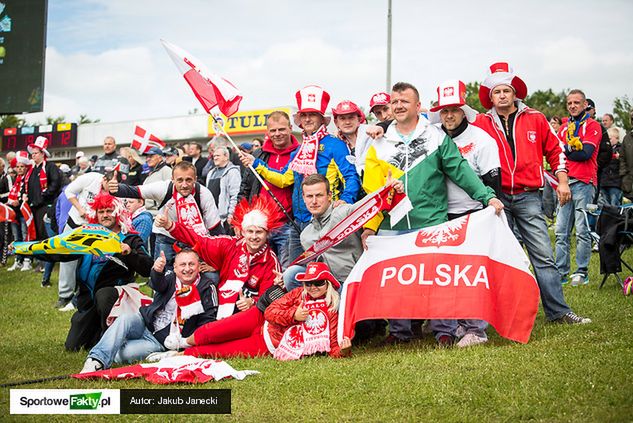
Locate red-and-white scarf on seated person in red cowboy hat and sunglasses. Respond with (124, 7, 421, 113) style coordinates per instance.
(273, 300, 330, 361)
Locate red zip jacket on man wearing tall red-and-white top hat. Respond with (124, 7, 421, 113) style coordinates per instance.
(475, 102, 567, 194)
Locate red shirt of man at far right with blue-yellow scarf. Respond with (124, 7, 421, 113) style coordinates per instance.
(558, 118, 602, 185)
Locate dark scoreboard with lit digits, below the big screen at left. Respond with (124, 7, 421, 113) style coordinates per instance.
(2, 123, 77, 152)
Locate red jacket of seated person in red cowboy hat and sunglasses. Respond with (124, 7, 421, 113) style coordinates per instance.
(264, 287, 341, 358)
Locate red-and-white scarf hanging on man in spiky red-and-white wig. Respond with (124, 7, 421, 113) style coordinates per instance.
(216, 242, 268, 320)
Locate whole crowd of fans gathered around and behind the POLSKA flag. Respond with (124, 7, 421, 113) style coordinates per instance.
(0, 63, 633, 371)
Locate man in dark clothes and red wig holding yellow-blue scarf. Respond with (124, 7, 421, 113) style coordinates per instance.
(38, 192, 154, 351)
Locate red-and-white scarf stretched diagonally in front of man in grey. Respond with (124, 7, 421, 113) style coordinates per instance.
(292, 186, 411, 265)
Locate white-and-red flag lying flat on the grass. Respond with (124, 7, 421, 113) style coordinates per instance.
(71, 355, 259, 385)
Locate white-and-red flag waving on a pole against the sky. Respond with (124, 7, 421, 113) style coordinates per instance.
(161, 40, 242, 116)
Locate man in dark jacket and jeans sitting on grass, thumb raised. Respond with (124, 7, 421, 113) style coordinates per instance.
(81, 249, 218, 373)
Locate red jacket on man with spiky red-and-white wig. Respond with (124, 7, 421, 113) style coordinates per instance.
(169, 222, 281, 301)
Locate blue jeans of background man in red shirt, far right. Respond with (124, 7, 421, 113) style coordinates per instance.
(556, 181, 595, 276)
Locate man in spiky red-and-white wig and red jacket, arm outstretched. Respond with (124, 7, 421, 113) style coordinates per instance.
(154, 196, 284, 320)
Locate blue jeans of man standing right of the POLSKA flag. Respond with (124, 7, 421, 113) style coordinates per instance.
(501, 191, 571, 320)
